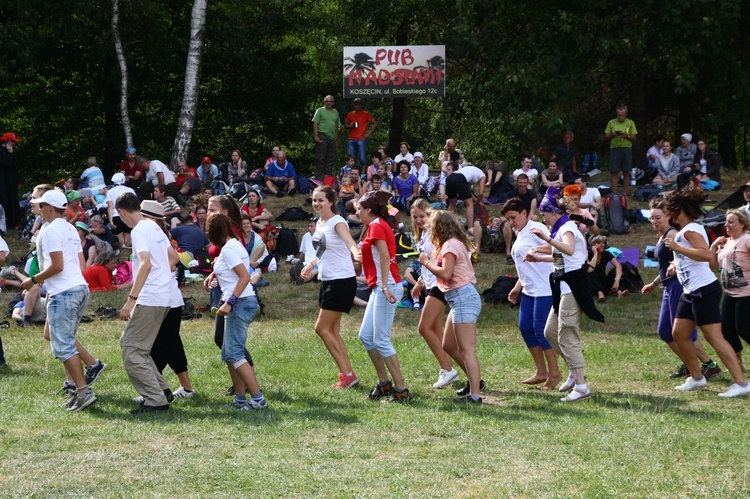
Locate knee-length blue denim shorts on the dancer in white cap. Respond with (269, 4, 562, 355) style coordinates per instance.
(47, 284, 89, 362)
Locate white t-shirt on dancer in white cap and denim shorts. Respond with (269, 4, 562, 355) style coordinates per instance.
(41, 218, 87, 296)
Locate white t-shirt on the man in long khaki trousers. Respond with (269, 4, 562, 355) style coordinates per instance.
(130, 219, 173, 308)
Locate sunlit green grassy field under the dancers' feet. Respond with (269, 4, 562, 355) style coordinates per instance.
(0, 175, 750, 497)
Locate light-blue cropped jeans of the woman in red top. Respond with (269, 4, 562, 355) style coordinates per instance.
(359, 282, 404, 359)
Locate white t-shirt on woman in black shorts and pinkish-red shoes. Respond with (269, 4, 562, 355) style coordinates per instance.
(312, 215, 355, 281)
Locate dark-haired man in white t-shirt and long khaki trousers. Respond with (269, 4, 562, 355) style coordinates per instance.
(115, 194, 172, 414)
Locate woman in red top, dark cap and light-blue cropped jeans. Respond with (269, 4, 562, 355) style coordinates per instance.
(357, 191, 410, 402)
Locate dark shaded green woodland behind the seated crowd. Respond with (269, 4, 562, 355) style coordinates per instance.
(0, 0, 750, 187)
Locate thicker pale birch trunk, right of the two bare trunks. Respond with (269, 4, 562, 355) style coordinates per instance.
(169, 0, 208, 170)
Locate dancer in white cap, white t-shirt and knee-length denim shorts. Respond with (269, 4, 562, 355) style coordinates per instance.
(21, 190, 97, 411)
